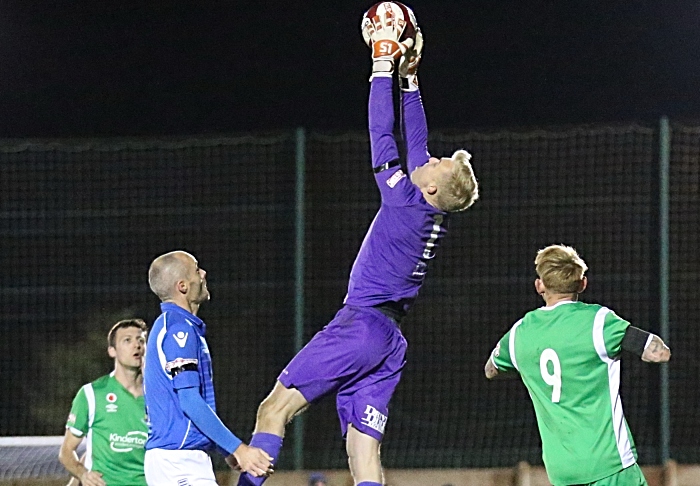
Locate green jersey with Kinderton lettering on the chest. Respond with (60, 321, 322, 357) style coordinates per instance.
(66, 374, 148, 486)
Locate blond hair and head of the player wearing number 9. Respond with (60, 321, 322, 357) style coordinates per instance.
(535, 245, 588, 294)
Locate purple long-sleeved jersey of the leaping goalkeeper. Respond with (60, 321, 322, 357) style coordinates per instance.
(345, 77, 448, 311)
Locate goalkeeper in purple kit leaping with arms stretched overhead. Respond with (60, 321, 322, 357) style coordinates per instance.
(238, 6, 478, 486)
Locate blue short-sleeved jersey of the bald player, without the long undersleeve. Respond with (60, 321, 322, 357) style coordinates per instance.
(143, 303, 216, 450)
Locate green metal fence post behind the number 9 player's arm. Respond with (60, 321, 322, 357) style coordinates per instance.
(659, 116, 671, 464)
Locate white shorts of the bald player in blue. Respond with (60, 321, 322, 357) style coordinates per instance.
(144, 449, 217, 486)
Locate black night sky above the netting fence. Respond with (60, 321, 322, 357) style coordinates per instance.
(0, 0, 700, 137)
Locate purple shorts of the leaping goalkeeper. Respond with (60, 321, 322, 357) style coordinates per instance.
(277, 306, 406, 441)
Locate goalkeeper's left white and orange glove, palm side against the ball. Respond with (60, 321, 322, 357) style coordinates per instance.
(362, 10, 413, 81)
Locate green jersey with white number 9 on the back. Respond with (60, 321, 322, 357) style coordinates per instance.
(491, 301, 637, 486)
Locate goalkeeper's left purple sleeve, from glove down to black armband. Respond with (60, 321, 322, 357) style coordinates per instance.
(369, 77, 399, 167)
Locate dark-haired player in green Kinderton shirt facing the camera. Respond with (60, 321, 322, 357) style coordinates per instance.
(59, 319, 148, 486)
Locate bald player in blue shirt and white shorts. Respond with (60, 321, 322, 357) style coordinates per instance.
(144, 251, 272, 485)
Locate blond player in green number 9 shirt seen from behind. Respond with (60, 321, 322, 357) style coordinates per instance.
(484, 245, 671, 486)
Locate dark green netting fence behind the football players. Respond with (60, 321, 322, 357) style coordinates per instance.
(0, 120, 700, 468)
